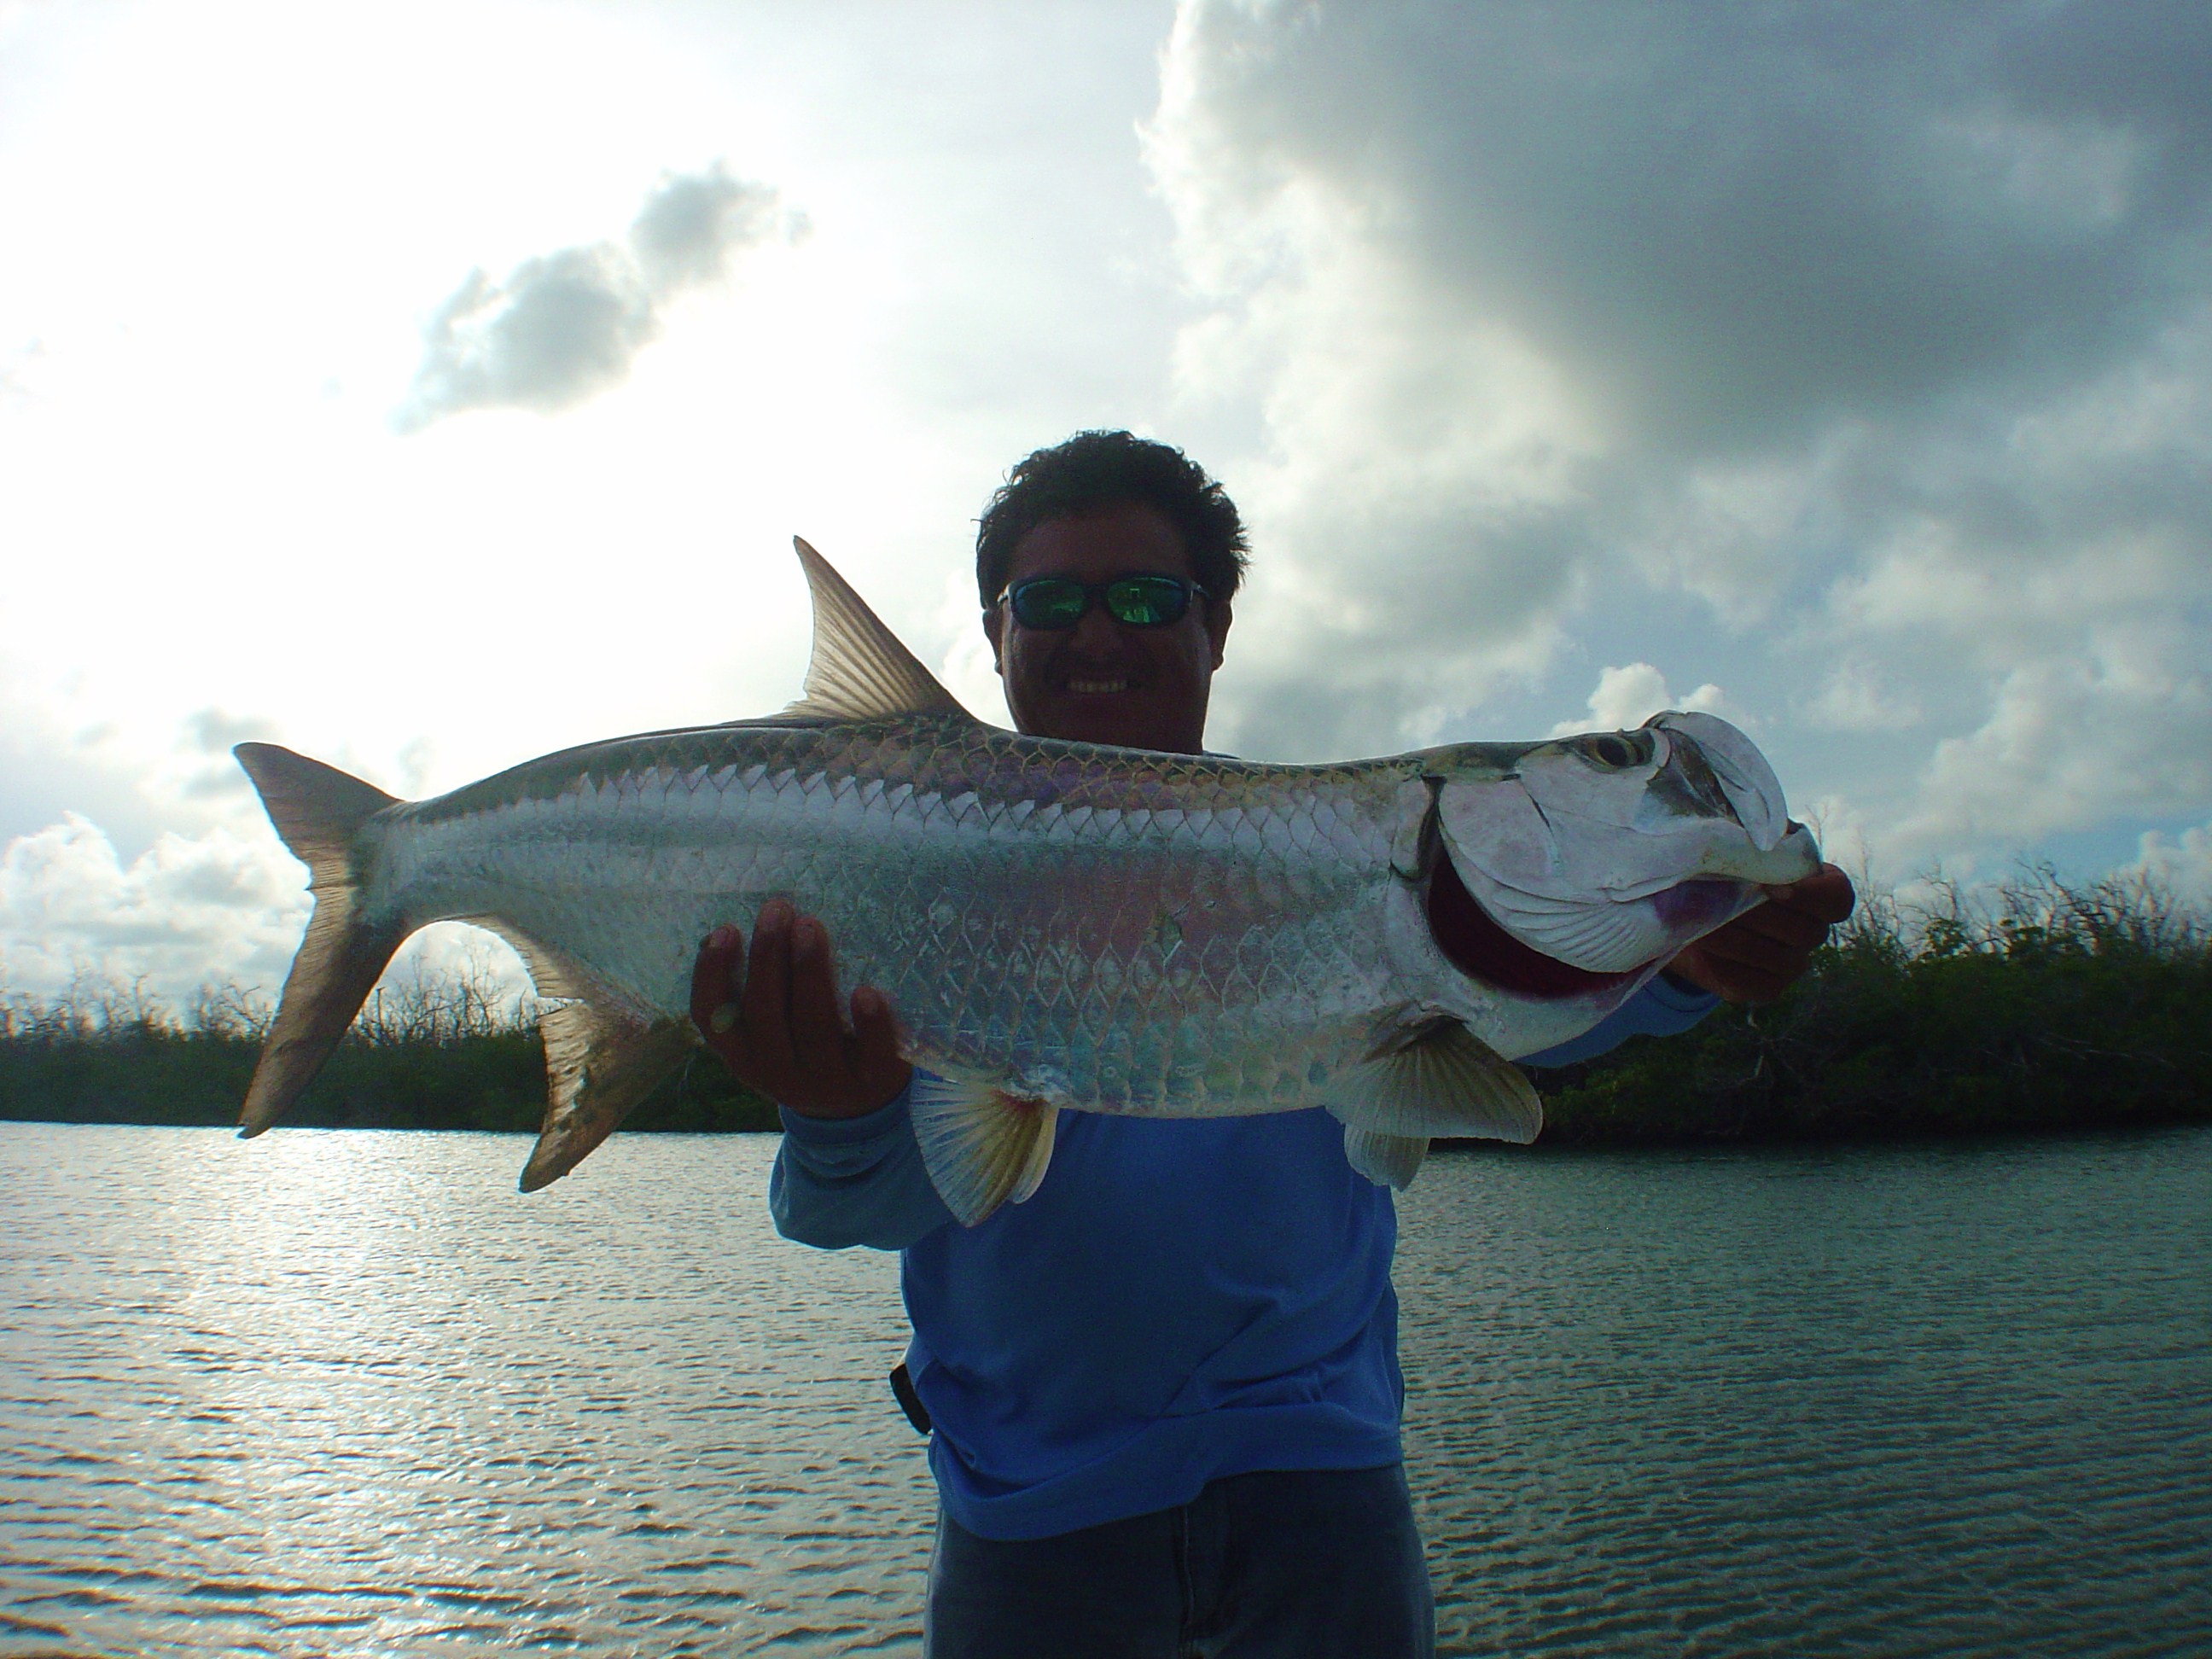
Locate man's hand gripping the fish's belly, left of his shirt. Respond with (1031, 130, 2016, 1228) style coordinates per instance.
(690, 898, 913, 1117)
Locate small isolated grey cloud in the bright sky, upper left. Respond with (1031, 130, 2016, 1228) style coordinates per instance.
(393, 161, 803, 431)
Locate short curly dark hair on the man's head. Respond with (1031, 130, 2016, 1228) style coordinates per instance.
(975, 431, 1245, 610)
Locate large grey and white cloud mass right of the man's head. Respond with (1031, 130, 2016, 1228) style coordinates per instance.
(1146, 0, 2212, 884)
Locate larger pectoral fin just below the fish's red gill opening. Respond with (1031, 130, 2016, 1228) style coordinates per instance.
(1330, 1020, 1544, 1179)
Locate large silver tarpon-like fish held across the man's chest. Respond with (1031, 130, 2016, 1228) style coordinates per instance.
(236, 542, 1819, 1223)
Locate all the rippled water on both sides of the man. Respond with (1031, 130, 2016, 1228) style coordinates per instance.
(0, 1124, 2212, 1659)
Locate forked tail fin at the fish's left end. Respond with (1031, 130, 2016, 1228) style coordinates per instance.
(232, 743, 410, 1137)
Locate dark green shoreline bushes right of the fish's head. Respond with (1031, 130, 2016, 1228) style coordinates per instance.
(1531, 864, 2212, 1144)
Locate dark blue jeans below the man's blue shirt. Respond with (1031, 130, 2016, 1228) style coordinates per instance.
(923, 1464, 1435, 1659)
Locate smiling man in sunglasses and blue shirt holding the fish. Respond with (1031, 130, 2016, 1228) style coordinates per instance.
(692, 431, 1852, 1659)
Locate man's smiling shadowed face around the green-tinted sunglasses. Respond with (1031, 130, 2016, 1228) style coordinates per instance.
(984, 504, 1230, 754)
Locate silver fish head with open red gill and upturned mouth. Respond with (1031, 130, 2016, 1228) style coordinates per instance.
(1420, 713, 1820, 1002)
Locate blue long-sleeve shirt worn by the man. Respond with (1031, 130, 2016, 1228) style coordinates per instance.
(767, 978, 1714, 1537)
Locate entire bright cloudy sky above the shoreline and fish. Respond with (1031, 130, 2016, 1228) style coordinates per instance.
(0, 0, 2212, 1008)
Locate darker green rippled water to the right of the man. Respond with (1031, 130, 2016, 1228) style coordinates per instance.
(1400, 1131, 2212, 1659)
